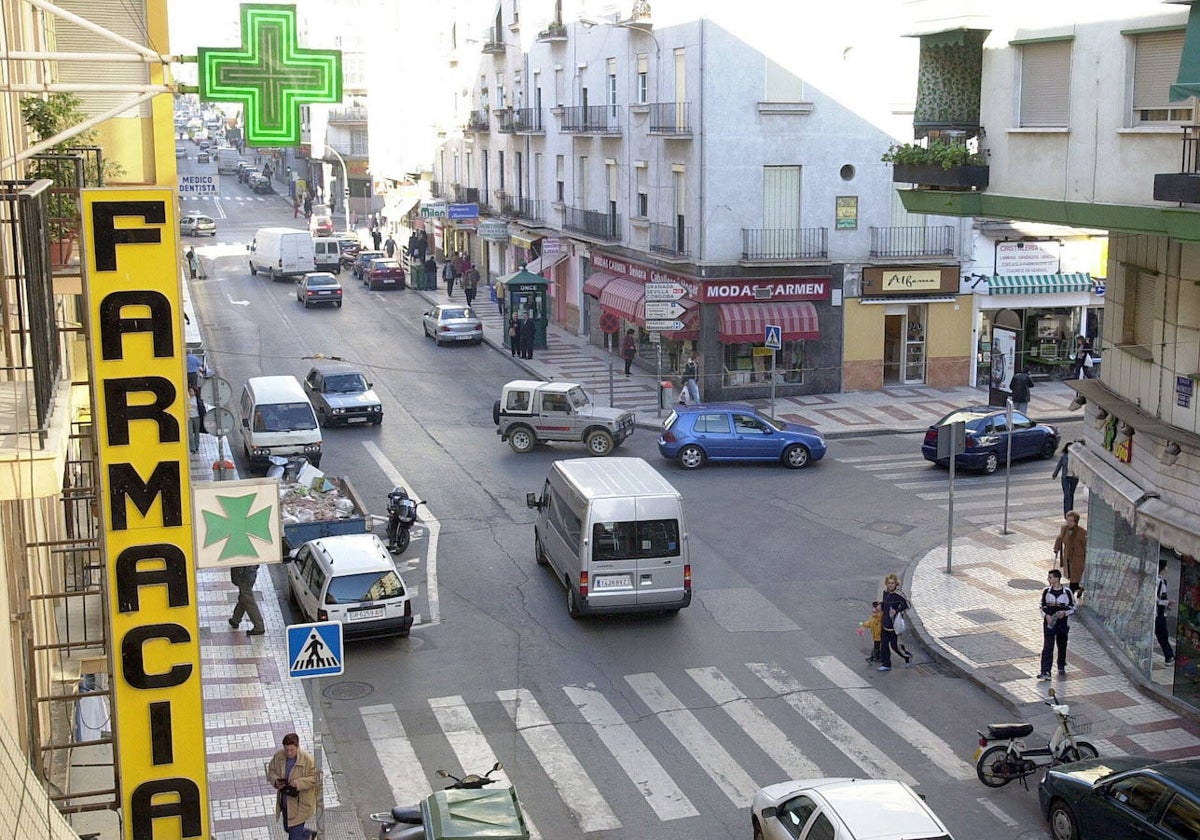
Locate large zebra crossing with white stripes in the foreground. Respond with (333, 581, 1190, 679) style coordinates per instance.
(359, 656, 976, 836)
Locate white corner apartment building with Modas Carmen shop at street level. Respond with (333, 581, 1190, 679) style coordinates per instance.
(432, 2, 971, 398)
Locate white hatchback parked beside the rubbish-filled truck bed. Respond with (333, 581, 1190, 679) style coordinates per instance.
(284, 534, 413, 638)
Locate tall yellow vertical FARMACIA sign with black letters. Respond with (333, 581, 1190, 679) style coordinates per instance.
(83, 188, 209, 840)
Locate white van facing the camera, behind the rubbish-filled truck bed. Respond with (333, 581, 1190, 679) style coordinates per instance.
(241, 377, 322, 470)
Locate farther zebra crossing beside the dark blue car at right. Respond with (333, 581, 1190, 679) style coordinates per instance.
(836, 452, 1065, 516)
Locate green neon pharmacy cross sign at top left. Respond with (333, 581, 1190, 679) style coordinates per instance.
(197, 4, 342, 146)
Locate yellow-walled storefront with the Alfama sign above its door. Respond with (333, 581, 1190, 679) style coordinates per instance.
(844, 264, 971, 391)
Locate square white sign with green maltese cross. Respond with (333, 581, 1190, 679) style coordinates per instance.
(192, 479, 280, 569)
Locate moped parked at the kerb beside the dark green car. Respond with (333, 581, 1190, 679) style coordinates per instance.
(976, 689, 1099, 790)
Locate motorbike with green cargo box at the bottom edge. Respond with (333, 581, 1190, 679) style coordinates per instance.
(371, 762, 529, 840)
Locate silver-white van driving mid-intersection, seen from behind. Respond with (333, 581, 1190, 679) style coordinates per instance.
(526, 458, 691, 618)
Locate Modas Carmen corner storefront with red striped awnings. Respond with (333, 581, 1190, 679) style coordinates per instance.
(582, 250, 841, 400)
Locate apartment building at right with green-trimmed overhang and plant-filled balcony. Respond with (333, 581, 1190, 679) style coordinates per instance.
(901, 1, 1200, 707)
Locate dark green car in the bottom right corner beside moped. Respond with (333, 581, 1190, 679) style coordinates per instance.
(1038, 756, 1200, 840)
